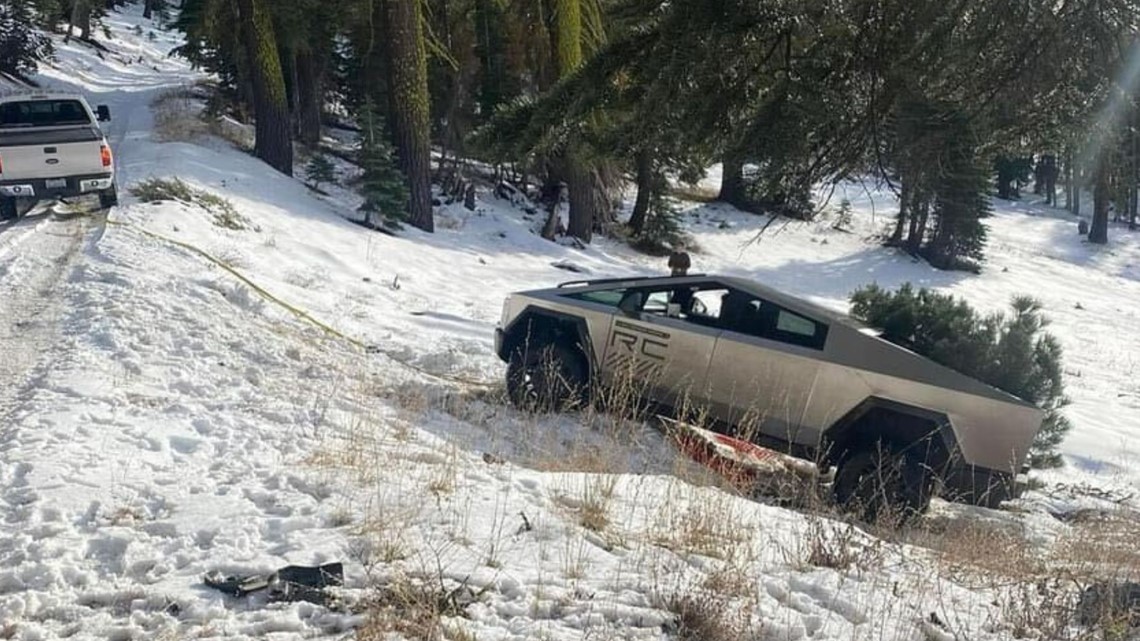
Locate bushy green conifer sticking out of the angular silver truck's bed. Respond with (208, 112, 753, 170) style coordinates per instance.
(852, 284, 1072, 468)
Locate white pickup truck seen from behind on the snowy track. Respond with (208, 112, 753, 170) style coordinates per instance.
(0, 94, 119, 220)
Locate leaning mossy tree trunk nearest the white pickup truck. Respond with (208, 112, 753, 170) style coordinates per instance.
(237, 0, 293, 176)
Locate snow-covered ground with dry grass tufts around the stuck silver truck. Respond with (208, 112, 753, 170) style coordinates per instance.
(0, 7, 1140, 641)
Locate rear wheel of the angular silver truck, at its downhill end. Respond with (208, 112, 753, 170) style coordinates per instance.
(832, 443, 934, 522)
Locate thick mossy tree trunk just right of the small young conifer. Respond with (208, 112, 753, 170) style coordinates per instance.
(385, 0, 435, 232)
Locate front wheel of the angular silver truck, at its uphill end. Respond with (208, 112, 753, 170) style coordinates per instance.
(506, 343, 586, 412)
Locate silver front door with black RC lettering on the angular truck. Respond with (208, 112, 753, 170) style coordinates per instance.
(603, 292, 720, 411)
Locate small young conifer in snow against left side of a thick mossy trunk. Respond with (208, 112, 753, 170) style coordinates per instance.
(357, 104, 408, 225)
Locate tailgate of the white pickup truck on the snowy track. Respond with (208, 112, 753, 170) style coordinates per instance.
(0, 127, 111, 181)
